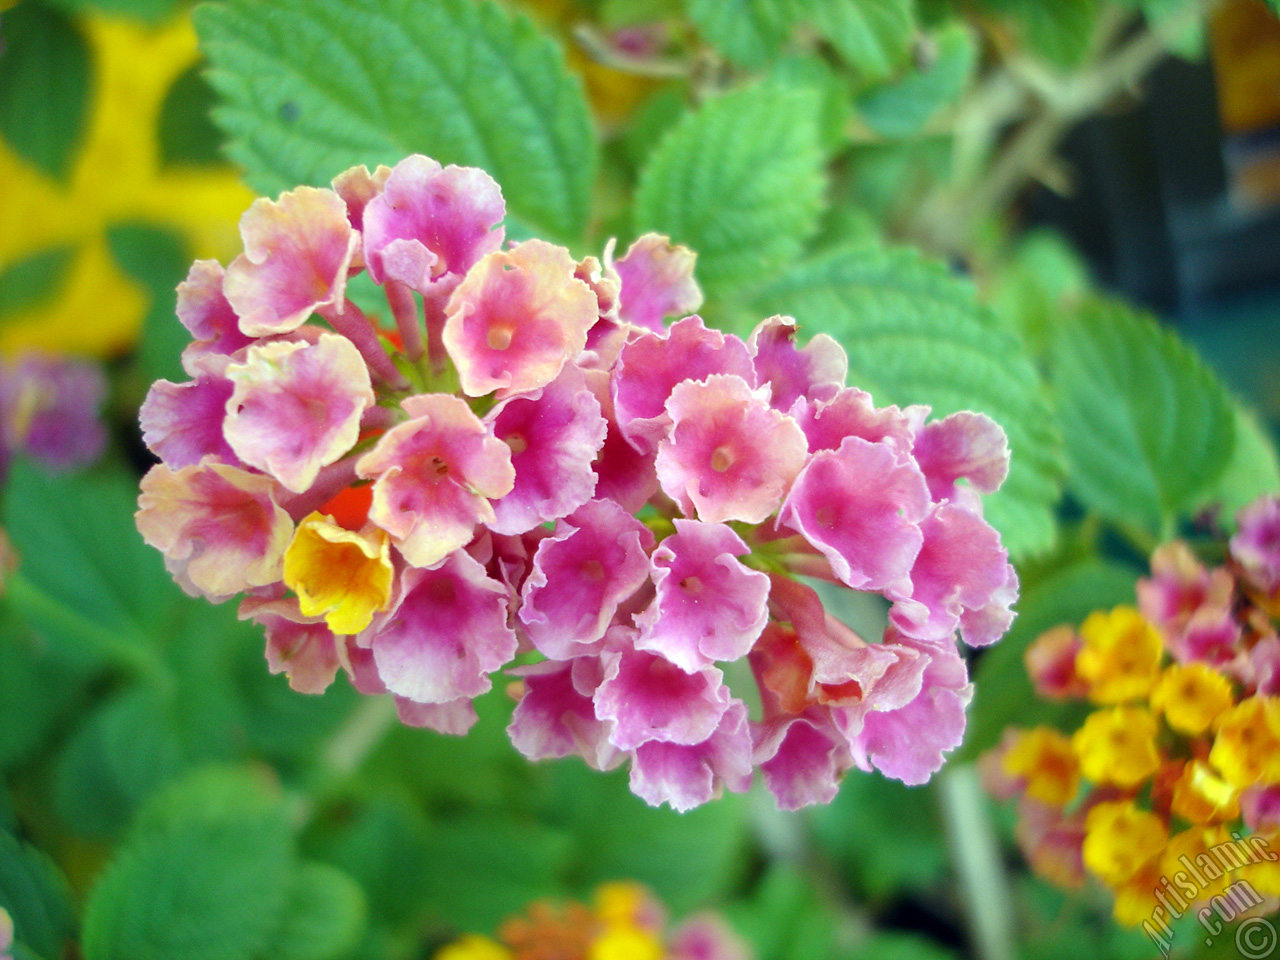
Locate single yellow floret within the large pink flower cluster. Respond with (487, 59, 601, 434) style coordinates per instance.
(284, 512, 392, 634)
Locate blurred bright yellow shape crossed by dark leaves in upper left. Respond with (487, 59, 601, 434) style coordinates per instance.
(0, 14, 253, 356)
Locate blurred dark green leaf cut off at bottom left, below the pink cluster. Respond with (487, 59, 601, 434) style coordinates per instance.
(83, 773, 292, 960)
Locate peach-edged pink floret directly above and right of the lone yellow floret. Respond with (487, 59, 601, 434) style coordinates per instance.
(356, 394, 516, 567)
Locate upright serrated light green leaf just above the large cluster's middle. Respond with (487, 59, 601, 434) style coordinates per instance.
(635, 84, 823, 297)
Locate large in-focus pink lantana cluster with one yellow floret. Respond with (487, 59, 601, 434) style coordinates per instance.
(137, 156, 1018, 809)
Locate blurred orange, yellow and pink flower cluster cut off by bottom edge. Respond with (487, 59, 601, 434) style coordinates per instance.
(435, 881, 753, 960)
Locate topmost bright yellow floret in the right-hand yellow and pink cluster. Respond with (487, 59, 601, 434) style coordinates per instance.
(1075, 607, 1164, 704)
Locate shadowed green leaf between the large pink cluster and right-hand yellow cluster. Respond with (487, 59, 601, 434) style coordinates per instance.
(951, 559, 1138, 763)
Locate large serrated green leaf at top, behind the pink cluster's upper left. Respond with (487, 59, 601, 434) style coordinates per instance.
(196, 0, 596, 239)
